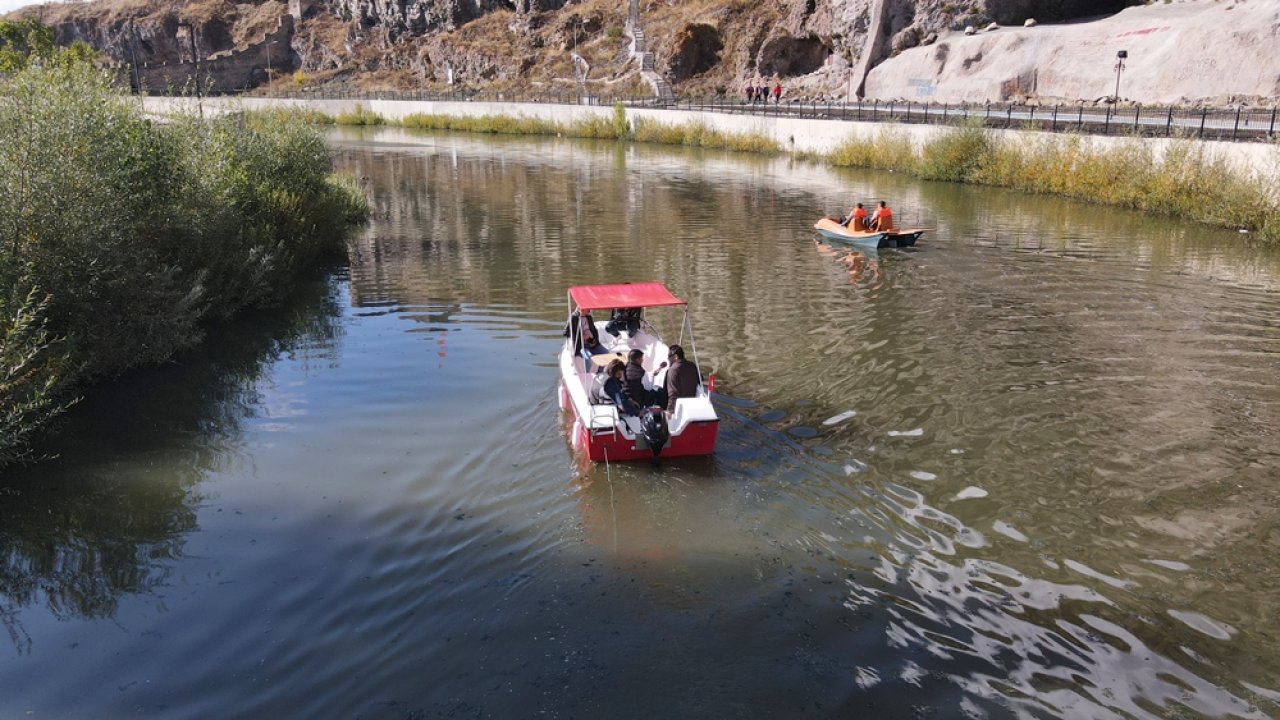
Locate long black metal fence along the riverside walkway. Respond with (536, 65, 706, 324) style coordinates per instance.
(217, 90, 1280, 141)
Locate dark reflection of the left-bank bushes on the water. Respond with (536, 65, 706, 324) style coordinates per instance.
(0, 271, 342, 653)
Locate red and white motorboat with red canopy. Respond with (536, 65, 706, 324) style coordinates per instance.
(559, 282, 719, 462)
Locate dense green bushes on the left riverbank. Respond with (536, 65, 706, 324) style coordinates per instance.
(0, 44, 367, 465)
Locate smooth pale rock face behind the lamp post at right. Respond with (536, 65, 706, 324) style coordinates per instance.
(865, 0, 1280, 104)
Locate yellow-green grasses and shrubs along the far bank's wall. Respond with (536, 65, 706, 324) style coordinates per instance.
(322, 105, 1280, 242)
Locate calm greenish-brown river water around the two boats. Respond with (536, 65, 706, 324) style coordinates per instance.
(0, 129, 1280, 717)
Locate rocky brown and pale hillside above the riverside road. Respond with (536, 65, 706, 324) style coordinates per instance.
(15, 0, 1280, 102)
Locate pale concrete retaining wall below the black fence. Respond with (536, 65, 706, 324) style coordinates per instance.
(143, 97, 1280, 184)
